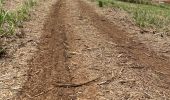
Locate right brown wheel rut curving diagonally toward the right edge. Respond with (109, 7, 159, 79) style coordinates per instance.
(79, 0, 170, 79)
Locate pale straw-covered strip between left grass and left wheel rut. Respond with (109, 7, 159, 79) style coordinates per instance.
(0, 0, 56, 100)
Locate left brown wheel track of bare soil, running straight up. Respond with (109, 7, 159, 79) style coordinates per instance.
(15, 0, 74, 100)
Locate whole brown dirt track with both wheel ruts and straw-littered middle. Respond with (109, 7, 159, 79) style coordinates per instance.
(13, 0, 170, 100)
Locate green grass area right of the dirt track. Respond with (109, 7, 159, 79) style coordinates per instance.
(97, 0, 170, 31)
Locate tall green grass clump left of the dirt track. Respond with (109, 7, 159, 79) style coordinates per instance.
(0, 0, 36, 36)
